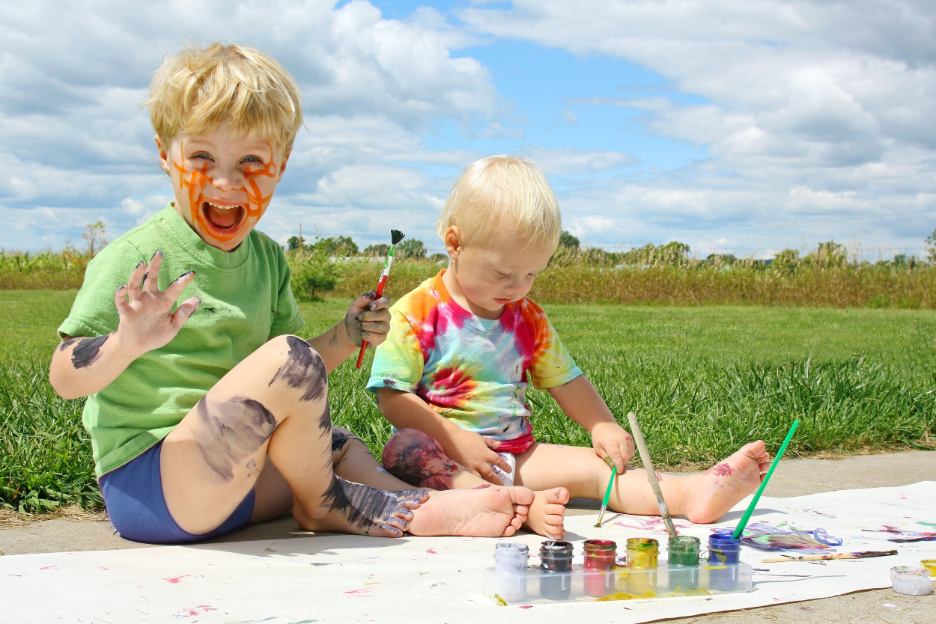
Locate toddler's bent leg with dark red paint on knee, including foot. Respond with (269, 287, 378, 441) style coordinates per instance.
(383, 429, 569, 539)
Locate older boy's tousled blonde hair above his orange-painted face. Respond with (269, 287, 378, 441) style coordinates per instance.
(146, 43, 302, 150)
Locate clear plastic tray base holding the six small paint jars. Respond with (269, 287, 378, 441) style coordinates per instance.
(484, 562, 753, 605)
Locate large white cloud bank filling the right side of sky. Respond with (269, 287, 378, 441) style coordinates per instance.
(460, 0, 936, 253)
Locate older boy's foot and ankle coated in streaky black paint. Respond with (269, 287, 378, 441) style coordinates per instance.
(293, 475, 429, 537)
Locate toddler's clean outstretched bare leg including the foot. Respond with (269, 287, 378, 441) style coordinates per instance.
(517, 441, 770, 523)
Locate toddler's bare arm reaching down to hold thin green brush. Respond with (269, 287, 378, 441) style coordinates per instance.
(549, 375, 634, 474)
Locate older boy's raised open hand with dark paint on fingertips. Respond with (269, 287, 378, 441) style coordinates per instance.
(114, 251, 200, 355)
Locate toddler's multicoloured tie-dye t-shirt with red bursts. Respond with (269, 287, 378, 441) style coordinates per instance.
(367, 270, 582, 440)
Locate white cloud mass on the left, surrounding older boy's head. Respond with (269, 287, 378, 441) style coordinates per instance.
(0, 0, 497, 249)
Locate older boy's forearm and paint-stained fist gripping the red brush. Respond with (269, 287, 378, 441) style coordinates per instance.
(307, 291, 390, 373)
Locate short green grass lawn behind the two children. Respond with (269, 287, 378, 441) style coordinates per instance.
(0, 291, 936, 511)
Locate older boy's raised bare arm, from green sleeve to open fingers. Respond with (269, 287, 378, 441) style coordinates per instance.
(49, 253, 199, 399)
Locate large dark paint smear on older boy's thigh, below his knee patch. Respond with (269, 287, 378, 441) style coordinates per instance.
(195, 396, 276, 481)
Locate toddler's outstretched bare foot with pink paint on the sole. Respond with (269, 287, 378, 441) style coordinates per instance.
(685, 440, 770, 524)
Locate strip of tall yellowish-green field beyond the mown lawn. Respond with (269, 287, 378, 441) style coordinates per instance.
(0, 252, 936, 310)
